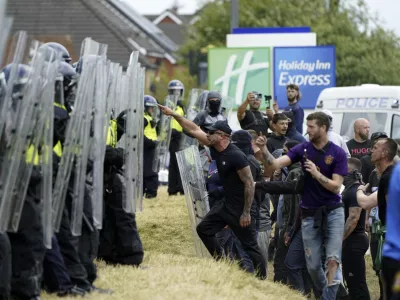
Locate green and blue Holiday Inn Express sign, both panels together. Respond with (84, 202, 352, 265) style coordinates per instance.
(208, 46, 336, 109)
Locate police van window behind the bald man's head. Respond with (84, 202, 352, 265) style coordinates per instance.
(340, 112, 387, 140)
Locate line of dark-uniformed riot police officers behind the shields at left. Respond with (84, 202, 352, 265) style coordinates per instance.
(0, 43, 148, 299)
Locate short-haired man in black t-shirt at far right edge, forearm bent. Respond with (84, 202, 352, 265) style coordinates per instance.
(357, 138, 398, 225)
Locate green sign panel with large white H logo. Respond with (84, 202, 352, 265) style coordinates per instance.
(208, 48, 272, 108)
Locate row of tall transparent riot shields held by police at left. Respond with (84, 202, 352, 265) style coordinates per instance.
(0, 29, 144, 248)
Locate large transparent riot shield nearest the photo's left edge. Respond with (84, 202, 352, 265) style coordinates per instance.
(0, 35, 44, 232)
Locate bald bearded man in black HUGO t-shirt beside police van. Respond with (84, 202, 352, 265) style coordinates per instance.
(347, 118, 371, 159)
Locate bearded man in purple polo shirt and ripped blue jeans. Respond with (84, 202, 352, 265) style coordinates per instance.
(257, 112, 347, 299)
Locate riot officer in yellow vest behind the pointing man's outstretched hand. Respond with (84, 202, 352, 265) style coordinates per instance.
(168, 80, 185, 196)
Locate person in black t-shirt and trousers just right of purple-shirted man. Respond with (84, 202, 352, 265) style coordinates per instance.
(342, 157, 370, 300)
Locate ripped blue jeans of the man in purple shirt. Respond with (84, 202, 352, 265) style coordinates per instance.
(301, 207, 344, 300)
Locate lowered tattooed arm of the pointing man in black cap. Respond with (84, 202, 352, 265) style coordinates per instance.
(237, 166, 254, 227)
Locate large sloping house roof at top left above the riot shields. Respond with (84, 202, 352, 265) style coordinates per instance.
(7, 0, 177, 68)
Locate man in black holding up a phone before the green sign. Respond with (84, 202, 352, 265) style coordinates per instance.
(237, 92, 269, 136)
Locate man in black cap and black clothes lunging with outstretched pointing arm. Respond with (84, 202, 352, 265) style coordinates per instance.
(159, 105, 266, 279)
